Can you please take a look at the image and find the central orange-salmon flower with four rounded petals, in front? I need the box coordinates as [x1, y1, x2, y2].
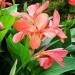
[13, 13, 49, 50]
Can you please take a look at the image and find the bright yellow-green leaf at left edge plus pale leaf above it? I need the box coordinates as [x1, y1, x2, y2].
[0, 5, 17, 42]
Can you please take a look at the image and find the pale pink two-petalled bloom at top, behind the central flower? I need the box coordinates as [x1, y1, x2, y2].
[27, 1, 49, 17]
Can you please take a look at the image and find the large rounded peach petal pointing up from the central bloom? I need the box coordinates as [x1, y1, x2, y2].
[35, 13, 49, 30]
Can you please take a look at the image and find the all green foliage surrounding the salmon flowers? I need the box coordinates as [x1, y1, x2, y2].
[0, 0, 75, 75]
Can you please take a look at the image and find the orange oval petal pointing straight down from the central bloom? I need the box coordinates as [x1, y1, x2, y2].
[30, 34, 41, 50]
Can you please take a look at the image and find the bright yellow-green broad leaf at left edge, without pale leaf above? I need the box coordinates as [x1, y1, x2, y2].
[0, 10, 15, 42]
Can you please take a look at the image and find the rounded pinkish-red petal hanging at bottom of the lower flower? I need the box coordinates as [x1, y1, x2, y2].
[38, 56, 52, 69]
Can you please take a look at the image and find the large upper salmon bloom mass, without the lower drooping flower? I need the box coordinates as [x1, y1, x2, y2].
[13, 1, 66, 50]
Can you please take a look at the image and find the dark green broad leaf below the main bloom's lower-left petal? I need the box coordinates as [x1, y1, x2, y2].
[7, 35, 31, 65]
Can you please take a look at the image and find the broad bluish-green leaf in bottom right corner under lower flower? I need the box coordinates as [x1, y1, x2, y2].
[37, 57, 75, 75]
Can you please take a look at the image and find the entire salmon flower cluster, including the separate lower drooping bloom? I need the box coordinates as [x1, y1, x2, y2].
[12, 1, 67, 69]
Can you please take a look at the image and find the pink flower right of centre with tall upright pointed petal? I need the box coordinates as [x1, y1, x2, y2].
[44, 10, 67, 43]
